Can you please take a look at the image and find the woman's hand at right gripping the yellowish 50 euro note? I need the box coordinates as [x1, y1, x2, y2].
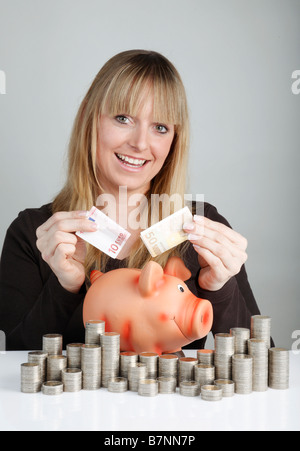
[183, 215, 248, 291]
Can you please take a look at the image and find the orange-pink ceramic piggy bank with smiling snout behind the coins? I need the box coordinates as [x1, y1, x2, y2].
[83, 257, 213, 355]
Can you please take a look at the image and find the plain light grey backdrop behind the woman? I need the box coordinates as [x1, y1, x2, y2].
[0, 0, 300, 348]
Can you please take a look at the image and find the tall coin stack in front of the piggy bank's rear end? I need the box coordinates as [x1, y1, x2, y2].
[100, 332, 120, 388]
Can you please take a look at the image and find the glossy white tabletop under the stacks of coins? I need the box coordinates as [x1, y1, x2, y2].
[0, 351, 300, 437]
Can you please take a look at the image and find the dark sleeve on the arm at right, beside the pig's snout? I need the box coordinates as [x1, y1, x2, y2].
[185, 204, 260, 348]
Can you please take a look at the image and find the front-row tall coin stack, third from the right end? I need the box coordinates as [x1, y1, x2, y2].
[232, 354, 253, 395]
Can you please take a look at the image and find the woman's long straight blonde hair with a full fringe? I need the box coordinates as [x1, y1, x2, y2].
[52, 50, 189, 275]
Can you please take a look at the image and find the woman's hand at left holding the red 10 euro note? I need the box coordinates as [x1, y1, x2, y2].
[36, 211, 97, 293]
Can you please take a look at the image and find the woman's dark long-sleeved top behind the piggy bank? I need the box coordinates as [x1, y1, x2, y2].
[0, 203, 260, 351]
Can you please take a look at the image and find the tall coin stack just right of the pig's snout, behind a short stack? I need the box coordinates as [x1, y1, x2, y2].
[214, 333, 235, 379]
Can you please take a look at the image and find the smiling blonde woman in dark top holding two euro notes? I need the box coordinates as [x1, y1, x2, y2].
[0, 50, 259, 349]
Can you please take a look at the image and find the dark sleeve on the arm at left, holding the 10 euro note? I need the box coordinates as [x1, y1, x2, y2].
[0, 209, 85, 350]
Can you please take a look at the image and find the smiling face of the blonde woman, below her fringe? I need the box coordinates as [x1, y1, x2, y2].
[97, 97, 174, 194]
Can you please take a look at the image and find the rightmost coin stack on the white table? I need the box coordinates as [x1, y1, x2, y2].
[269, 348, 289, 390]
